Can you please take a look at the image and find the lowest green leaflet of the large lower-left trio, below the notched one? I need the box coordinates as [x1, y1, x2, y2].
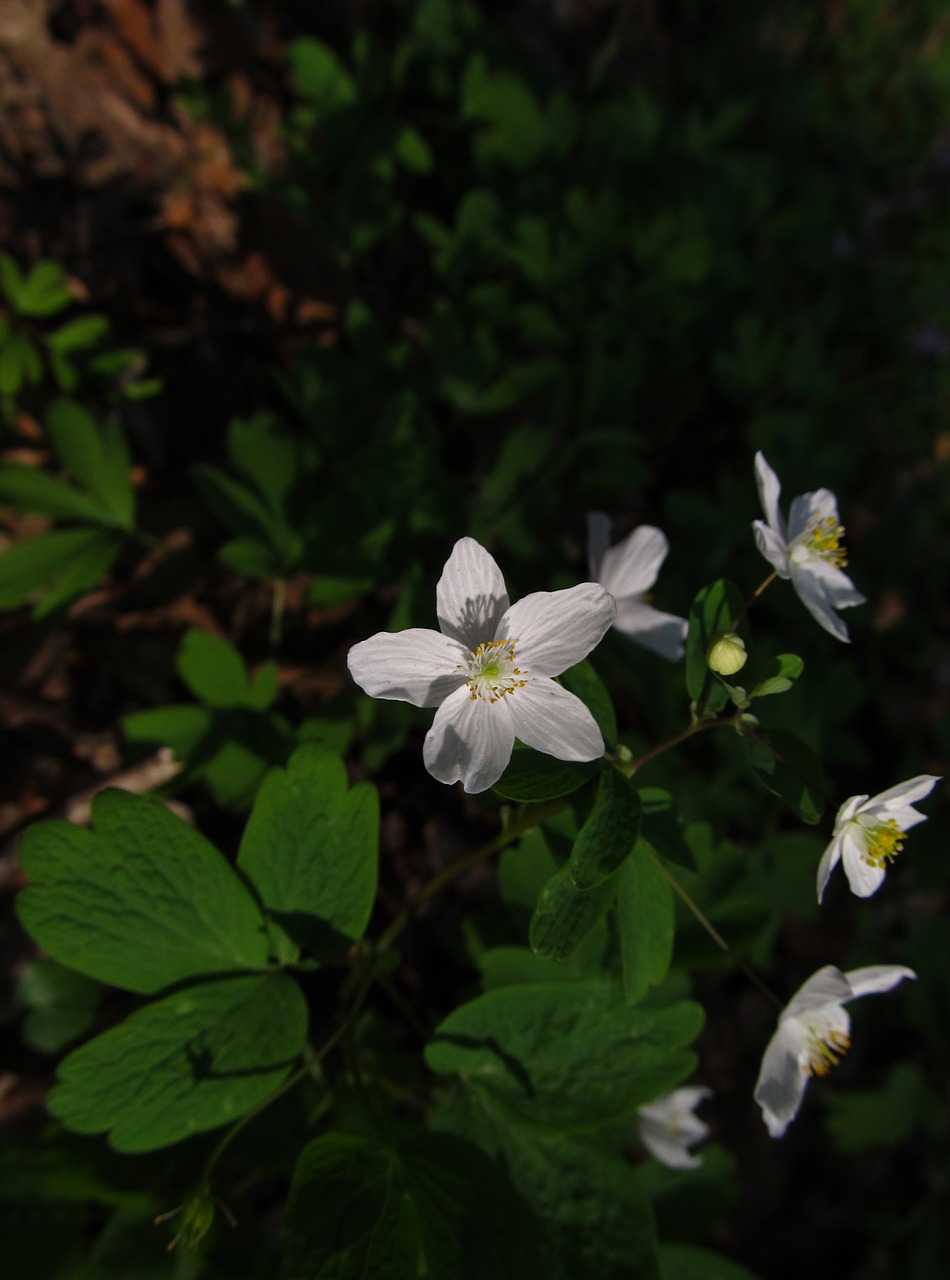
[47, 973, 307, 1152]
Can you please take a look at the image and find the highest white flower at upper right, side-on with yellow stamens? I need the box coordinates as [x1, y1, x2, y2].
[753, 453, 864, 643]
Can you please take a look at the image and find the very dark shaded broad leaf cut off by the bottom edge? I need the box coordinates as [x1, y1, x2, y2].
[279, 1133, 473, 1280]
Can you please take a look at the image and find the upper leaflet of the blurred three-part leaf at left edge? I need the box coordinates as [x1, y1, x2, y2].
[46, 399, 136, 529]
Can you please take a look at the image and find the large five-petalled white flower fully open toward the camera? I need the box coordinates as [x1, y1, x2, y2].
[347, 538, 616, 792]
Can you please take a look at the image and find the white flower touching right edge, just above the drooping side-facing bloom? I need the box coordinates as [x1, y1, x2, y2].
[818, 773, 940, 902]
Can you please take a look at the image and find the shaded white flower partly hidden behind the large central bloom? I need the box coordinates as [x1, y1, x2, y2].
[588, 511, 688, 662]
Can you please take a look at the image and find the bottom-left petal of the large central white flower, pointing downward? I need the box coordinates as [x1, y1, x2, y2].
[423, 689, 515, 794]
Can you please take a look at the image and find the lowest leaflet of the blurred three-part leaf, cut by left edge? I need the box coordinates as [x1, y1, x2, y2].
[0, 529, 120, 614]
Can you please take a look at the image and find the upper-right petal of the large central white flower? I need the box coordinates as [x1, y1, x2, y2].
[494, 582, 617, 678]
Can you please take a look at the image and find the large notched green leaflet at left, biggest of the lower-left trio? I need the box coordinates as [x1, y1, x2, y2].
[17, 791, 268, 993]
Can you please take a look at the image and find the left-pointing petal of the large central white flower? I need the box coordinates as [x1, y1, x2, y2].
[347, 627, 467, 707]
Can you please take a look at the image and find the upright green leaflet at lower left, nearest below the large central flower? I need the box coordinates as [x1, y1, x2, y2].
[238, 744, 379, 960]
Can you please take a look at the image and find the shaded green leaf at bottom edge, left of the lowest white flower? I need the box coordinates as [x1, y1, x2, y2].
[435, 1082, 657, 1280]
